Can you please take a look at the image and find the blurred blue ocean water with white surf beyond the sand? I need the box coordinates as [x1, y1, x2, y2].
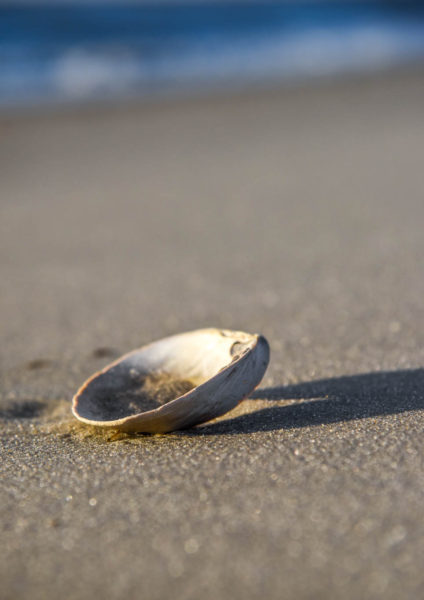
[0, 0, 424, 107]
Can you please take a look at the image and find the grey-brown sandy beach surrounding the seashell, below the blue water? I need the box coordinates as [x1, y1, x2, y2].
[0, 71, 424, 600]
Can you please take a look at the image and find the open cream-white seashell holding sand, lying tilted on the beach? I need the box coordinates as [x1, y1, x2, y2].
[72, 329, 269, 433]
